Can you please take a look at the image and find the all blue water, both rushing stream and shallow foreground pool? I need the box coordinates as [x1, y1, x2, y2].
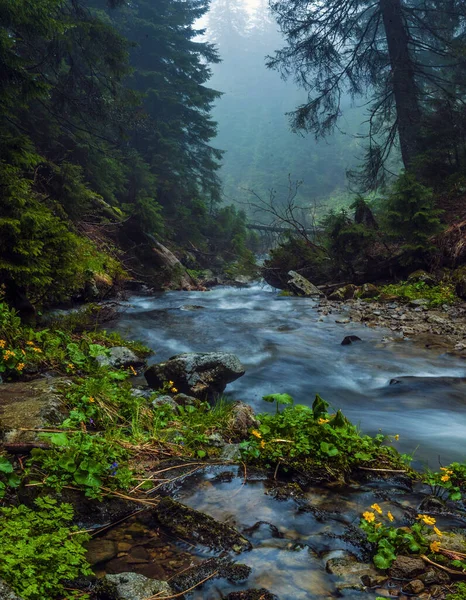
[104, 285, 466, 600]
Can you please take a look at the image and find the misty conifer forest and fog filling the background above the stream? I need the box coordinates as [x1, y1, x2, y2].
[0, 0, 466, 312]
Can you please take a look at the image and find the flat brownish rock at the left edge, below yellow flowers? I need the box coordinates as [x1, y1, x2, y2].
[0, 377, 71, 444]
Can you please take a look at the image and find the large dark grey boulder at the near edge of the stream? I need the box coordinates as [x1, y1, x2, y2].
[145, 352, 245, 399]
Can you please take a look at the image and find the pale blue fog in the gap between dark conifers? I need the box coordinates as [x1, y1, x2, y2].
[201, 0, 365, 212]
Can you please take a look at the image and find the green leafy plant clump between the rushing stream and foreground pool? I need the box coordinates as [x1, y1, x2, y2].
[241, 394, 408, 473]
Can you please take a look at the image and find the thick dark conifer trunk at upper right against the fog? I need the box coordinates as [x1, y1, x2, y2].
[379, 0, 421, 170]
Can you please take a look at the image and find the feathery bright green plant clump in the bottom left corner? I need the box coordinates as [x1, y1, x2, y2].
[0, 497, 92, 600]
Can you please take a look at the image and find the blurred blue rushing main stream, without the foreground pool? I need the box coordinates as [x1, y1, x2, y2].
[117, 285, 466, 467]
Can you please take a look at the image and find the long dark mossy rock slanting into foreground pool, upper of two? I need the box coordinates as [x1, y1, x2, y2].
[154, 497, 251, 552]
